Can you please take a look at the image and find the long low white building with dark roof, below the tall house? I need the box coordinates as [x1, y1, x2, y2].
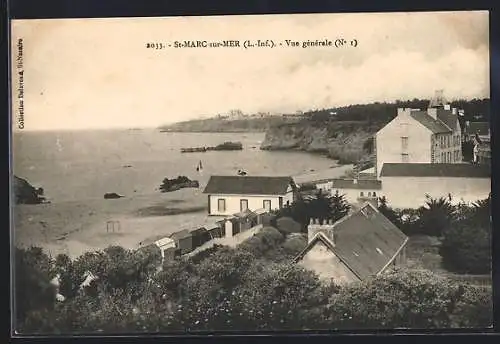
[380, 163, 491, 208]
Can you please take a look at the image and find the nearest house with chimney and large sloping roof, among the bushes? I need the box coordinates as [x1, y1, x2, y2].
[294, 203, 408, 284]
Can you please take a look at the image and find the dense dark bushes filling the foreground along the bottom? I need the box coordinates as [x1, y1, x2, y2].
[16, 223, 492, 333]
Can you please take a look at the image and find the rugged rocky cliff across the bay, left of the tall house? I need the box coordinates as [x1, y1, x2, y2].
[260, 120, 385, 166]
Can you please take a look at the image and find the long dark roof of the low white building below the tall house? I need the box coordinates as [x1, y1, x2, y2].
[380, 163, 491, 178]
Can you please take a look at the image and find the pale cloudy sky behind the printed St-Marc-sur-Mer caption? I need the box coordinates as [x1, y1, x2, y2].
[11, 11, 490, 130]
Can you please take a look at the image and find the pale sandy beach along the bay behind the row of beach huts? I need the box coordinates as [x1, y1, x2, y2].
[13, 165, 351, 258]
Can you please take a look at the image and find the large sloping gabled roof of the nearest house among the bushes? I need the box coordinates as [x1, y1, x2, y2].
[294, 203, 408, 279]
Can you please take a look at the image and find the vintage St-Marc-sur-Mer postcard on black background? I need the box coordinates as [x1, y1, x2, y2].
[10, 11, 492, 335]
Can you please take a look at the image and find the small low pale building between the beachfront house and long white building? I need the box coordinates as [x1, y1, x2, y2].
[315, 178, 382, 204]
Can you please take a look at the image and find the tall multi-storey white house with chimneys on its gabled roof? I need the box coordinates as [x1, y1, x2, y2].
[375, 104, 462, 177]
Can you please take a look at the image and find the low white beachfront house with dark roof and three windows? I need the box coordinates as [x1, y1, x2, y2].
[203, 176, 297, 216]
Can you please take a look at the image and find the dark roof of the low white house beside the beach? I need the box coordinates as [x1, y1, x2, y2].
[203, 176, 293, 195]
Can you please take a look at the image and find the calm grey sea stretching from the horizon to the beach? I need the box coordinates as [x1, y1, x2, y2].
[12, 129, 334, 203]
